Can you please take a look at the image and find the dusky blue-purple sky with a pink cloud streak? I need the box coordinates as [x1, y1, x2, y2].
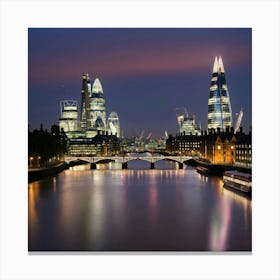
[28, 28, 252, 137]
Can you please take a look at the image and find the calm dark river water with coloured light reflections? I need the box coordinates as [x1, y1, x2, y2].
[28, 158, 252, 252]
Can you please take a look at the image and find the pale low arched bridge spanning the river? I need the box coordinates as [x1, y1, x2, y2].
[65, 155, 192, 169]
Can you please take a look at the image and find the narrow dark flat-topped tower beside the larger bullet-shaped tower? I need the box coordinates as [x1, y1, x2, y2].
[80, 74, 91, 130]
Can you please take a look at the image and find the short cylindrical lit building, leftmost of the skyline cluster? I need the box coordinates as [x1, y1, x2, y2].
[59, 100, 79, 135]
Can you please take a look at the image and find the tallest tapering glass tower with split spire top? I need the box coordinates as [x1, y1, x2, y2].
[208, 56, 232, 131]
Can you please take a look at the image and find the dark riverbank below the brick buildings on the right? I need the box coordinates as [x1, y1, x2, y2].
[186, 159, 252, 177]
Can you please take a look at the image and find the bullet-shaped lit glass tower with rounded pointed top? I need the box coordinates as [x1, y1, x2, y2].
[90, 78, 106, 131]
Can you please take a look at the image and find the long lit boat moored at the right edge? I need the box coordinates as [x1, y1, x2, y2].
[223, 170, 252, 193]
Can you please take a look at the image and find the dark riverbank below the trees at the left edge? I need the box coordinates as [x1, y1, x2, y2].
[28, 162, 69, 183]
